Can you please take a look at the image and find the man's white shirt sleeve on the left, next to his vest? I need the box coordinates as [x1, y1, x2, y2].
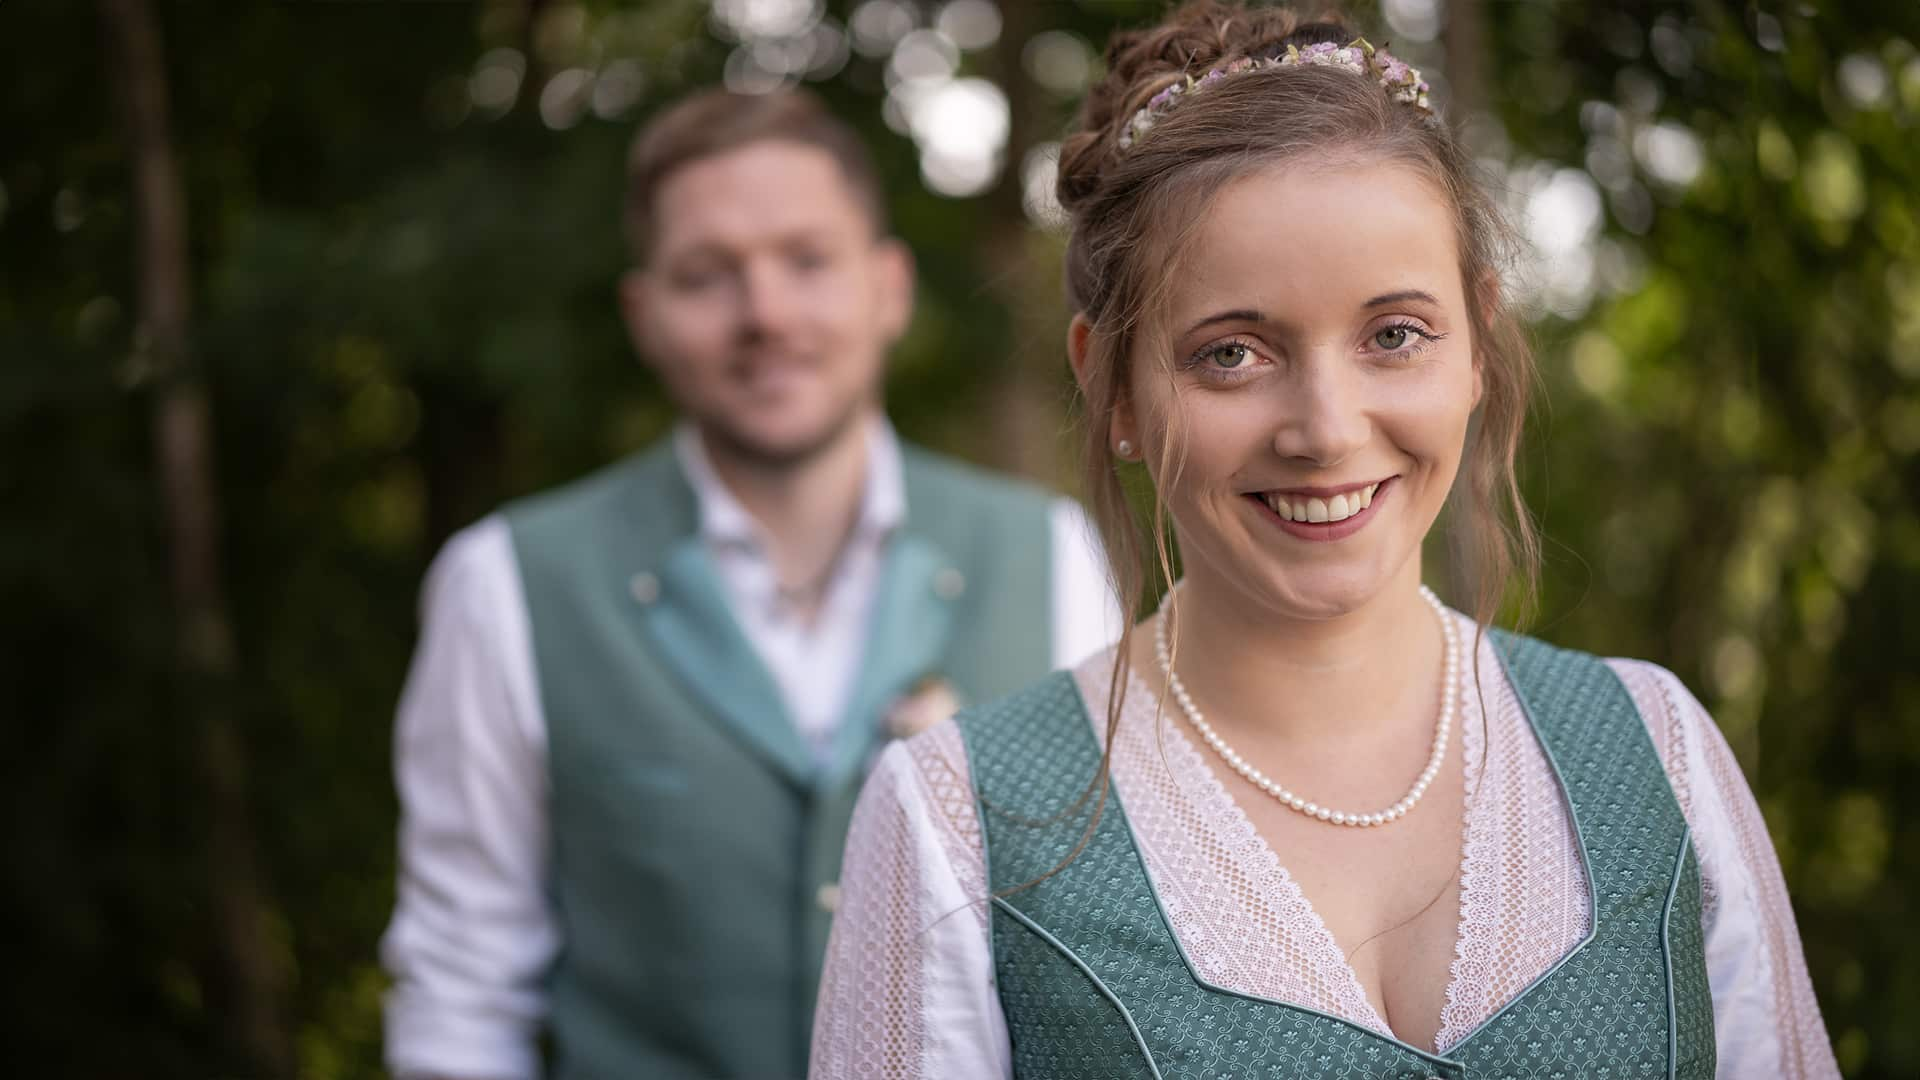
[380, 517, 557, 1080]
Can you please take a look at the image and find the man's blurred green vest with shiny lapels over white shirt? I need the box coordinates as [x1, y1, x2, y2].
[507, 446, 1052, 1080]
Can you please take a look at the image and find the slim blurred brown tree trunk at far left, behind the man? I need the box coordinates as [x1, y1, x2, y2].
[100, 0, 292, 1076]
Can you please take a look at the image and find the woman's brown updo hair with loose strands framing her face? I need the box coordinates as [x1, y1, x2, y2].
[1058, 0, 1538, 868]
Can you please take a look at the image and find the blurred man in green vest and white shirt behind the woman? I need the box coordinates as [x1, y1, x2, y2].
[382, 92, 1117, 1080]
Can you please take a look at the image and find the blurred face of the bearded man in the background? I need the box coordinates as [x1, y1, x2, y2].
[620, 140, 912, 465]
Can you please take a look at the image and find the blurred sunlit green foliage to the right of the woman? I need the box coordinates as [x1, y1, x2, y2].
[1496, 4, 1920, 1076]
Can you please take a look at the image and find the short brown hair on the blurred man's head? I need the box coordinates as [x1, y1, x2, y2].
[624, 88, 887, 261]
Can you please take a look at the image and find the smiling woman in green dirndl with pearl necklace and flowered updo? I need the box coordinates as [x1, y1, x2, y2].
[814, 4, 1837, 1078]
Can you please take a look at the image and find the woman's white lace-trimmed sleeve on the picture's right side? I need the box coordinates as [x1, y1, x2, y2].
[1613, 661, 1839, 1080]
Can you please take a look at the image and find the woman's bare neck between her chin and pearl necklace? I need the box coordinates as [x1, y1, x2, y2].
[1135, 561, 1444, 748]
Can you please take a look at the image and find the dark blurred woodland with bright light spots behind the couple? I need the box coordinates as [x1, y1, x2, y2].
[0, 0, 1920, 1078]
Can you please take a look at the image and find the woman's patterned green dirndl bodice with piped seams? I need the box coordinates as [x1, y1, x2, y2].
[960, 630, 1715, 1080]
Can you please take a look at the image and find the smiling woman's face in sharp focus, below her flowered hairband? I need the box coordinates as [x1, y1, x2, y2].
[1112, 155, 1480, 619]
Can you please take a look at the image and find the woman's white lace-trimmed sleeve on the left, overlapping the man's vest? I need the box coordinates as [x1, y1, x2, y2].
[810, 721, 1012, 1080]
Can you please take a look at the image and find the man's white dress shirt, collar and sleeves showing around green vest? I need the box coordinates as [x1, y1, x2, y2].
[380, 421, 1119, 1078]
